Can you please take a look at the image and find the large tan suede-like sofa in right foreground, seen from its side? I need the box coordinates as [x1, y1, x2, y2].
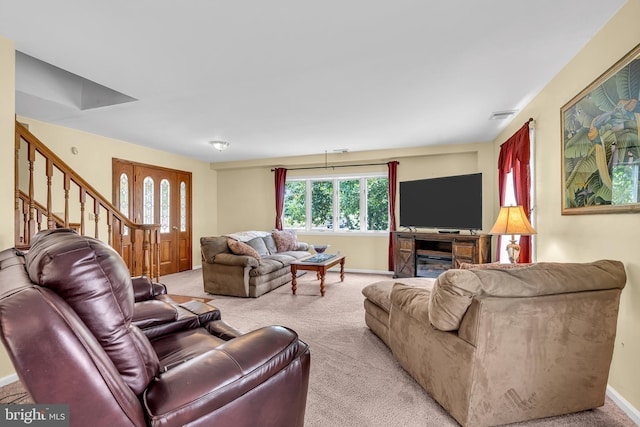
[363, 260, 626, 426]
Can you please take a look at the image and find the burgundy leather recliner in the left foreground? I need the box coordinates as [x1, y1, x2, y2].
[0, 230, 310, 427]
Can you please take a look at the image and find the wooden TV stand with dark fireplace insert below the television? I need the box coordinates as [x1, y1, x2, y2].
[393, 231, 491, 277]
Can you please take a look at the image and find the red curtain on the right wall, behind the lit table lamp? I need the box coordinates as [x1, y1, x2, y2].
[496, 119, 533, 263]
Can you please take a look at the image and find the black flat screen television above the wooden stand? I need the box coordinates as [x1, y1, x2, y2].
[399, 173, 482, 231]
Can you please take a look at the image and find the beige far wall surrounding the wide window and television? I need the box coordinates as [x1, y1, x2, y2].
[212, 143, 496, 272]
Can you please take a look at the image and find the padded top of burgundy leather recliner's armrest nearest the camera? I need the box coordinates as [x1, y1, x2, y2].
[143, 326, 308, 425]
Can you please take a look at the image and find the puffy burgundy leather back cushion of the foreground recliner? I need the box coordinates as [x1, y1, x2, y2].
[25, 229, 160, 394]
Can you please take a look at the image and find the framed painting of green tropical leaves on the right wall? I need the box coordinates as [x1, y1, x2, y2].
[560, 45, 640, 215]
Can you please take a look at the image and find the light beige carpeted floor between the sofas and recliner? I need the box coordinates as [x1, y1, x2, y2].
[0, 270, 635, 427]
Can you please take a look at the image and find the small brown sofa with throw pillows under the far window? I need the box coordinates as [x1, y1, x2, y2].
[200, 231, 311, 298]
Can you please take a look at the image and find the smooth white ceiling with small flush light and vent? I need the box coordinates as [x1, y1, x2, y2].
[0, 0, 626, 162]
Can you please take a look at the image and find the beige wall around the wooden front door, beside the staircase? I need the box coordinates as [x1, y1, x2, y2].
[12, 117, 217, 266]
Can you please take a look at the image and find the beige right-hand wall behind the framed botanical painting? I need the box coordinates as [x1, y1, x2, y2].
[494, 0, 640, 408]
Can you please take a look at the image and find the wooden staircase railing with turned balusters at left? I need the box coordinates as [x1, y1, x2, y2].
[15, 121, 160, 280]
